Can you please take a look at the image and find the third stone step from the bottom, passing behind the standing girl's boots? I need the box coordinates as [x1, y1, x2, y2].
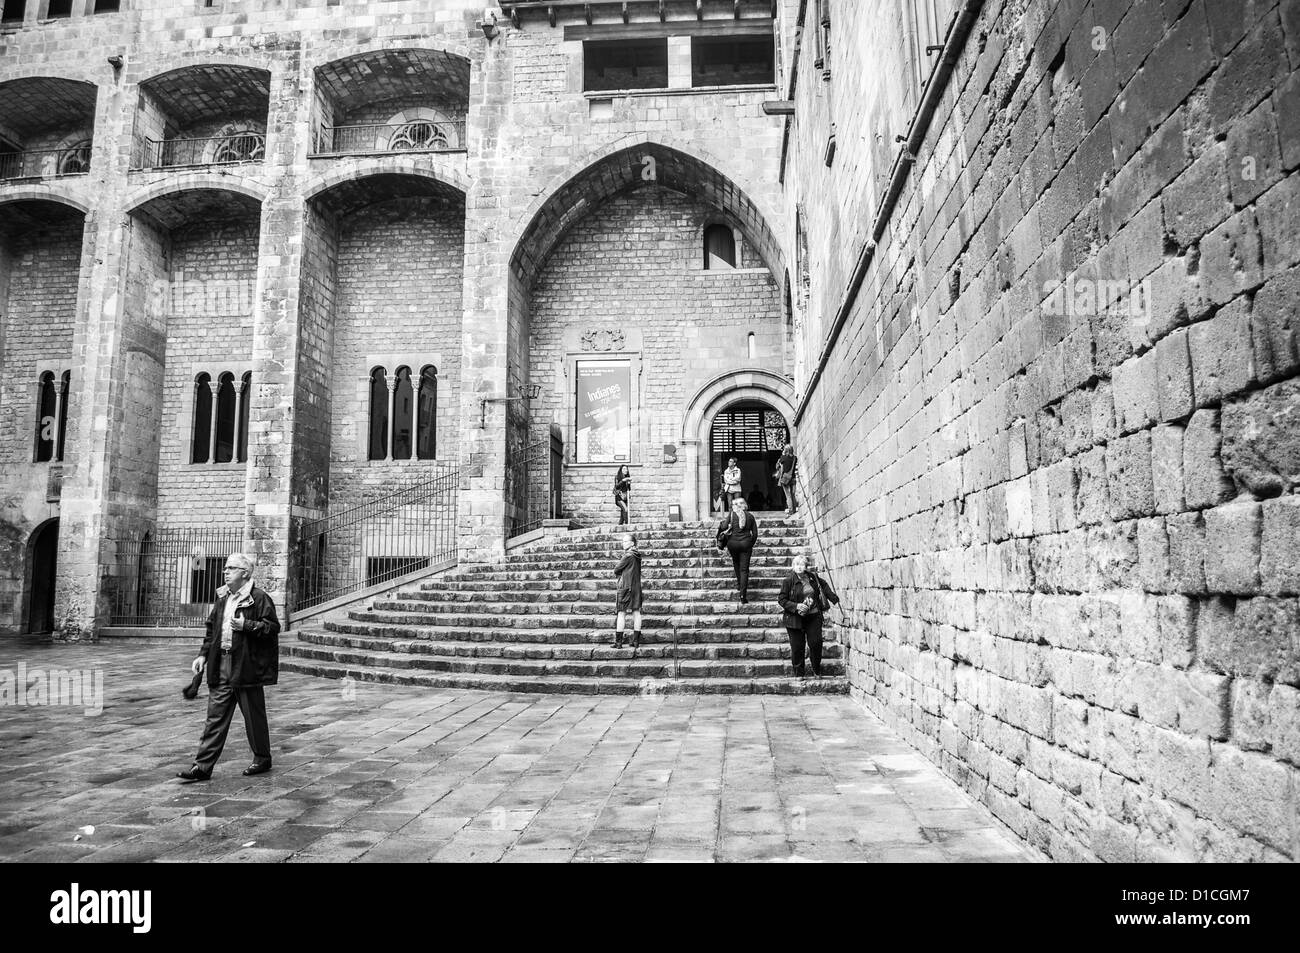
[321, 610, 800, 645]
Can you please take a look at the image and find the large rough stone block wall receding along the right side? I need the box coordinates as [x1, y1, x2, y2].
[788, 0, 1300, 861]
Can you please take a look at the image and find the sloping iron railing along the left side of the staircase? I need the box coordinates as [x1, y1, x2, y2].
[293, 463, 460, 612]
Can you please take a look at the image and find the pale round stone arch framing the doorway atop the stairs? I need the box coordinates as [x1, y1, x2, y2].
[681, 369, 794, 519]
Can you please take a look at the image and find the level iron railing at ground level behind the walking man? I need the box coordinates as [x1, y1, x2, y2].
[109, 525, 244, 628]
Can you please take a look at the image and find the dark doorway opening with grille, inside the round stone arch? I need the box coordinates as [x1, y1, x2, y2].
[709, 399, 789, 512]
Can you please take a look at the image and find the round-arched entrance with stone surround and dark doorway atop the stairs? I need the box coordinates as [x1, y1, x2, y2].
[681, 368, 798, 520]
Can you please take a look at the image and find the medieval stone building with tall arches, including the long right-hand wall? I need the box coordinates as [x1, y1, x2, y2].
[0, 0, 1300, 859]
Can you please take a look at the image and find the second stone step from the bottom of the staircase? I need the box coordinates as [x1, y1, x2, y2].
[298, 629, 842, 660]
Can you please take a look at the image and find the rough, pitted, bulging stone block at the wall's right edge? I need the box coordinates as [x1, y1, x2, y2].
[1216, 380, 1300, 497]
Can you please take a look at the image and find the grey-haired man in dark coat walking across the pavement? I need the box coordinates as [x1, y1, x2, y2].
[177, 553, 280, 781]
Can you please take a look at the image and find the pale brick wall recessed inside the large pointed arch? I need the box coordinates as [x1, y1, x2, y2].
[529, 187, 784, 520]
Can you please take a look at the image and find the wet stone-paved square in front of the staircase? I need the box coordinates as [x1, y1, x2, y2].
[0, 641, 1035, 862]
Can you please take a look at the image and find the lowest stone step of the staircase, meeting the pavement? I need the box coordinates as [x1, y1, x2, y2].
[280, 657, 849, 696]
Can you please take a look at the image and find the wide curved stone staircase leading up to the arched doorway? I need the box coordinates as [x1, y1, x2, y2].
[281, 515, 848, 694]
